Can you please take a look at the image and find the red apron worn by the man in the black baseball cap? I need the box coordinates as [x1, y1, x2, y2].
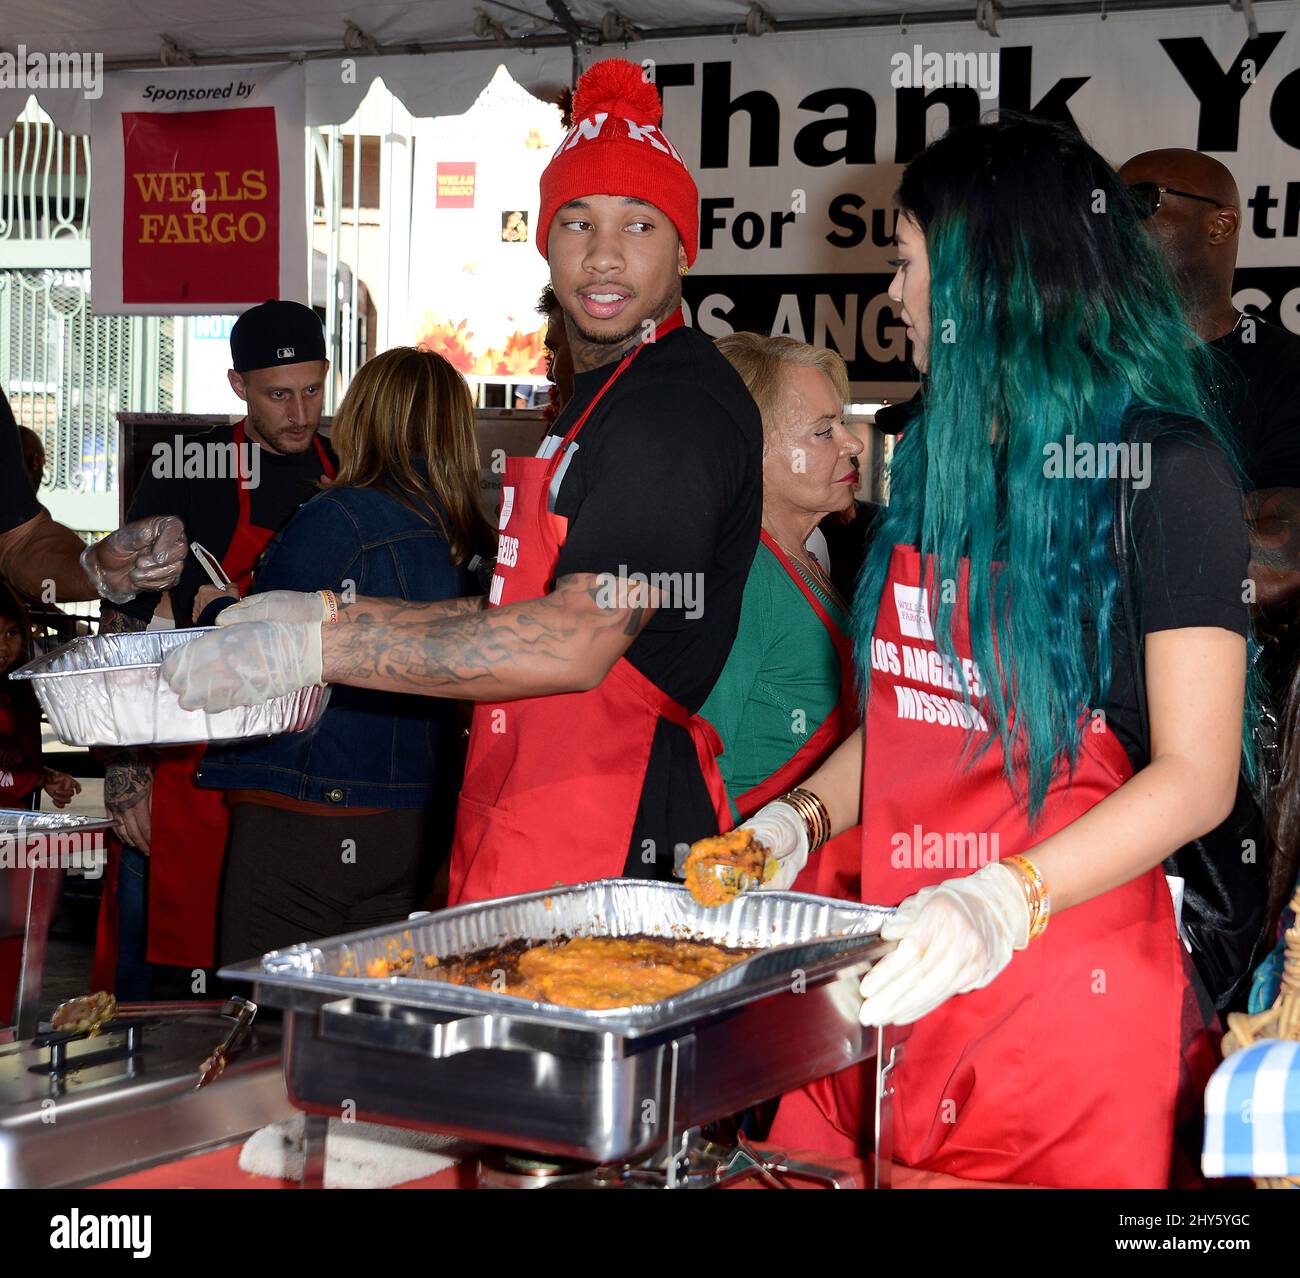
[95, 419, 334, 972]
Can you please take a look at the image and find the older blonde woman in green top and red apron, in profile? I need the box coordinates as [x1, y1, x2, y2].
[699, 333, 862, 893]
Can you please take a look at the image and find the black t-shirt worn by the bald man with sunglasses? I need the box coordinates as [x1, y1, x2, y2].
[1209, 316, 1300, 489]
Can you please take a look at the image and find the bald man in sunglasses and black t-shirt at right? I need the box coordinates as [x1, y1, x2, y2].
[1119, 150, 1300, 619]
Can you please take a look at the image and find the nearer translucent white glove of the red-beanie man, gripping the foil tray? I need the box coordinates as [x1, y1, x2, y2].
[163, 621, 324, 712]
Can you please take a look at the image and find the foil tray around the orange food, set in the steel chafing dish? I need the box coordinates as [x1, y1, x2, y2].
[221, 879, 893, 1037]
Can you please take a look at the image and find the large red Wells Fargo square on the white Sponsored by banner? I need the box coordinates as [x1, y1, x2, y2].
[122, 107, 281, 306]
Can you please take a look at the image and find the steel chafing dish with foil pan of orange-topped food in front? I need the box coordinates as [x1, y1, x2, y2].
[221, 879, 891, 1162]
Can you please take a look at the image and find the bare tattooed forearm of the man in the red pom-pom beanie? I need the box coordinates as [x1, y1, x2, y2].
[322, 573, 654, 701]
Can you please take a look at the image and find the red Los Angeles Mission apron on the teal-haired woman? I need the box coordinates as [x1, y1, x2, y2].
[771, 546, 1186, 1188]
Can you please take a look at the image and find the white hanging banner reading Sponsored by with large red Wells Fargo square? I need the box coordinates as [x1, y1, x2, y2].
[91, 68, 307, 315]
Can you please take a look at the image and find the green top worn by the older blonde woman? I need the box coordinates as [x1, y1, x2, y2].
[699, 543, 848, 820]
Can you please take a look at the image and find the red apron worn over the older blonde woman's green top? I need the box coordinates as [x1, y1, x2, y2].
[736, 528, 862, 898]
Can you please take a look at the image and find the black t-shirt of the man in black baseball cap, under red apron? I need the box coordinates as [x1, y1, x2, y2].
[113, 425, 335, 627]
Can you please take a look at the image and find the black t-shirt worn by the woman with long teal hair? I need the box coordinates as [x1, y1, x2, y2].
[1086, 417, 1251, 770]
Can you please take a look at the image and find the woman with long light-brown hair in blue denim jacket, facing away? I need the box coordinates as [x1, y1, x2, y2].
[199, 347, 493, 963]
